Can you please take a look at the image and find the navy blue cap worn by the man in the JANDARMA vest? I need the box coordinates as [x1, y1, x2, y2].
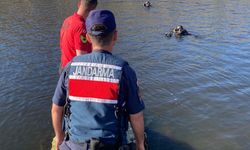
[86, 10, 116, 36]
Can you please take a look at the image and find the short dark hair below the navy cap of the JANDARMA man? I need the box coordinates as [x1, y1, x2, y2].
[89, 24, 115, 46]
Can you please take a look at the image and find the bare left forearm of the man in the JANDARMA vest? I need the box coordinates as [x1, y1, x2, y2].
[51, 104, 65, 150]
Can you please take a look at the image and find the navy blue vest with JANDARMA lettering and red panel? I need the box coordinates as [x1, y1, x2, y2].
[67, 51, 127, 144]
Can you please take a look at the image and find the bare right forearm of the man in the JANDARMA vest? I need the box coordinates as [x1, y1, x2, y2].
[129, 111, 145, 150]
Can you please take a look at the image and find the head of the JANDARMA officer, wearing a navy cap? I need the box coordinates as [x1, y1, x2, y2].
[86, 10, 117, 51]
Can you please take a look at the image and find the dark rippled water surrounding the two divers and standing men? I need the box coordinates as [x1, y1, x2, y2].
[0, 0, 250, 150]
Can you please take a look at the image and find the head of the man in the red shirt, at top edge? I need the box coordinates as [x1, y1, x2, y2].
[77, 0, 98, 19]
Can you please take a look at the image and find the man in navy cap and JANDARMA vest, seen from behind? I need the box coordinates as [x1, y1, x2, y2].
[51, 10, 145, 150]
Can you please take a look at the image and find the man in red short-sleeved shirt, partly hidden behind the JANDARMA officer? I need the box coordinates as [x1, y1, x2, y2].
[60, 0, 97, 72]
